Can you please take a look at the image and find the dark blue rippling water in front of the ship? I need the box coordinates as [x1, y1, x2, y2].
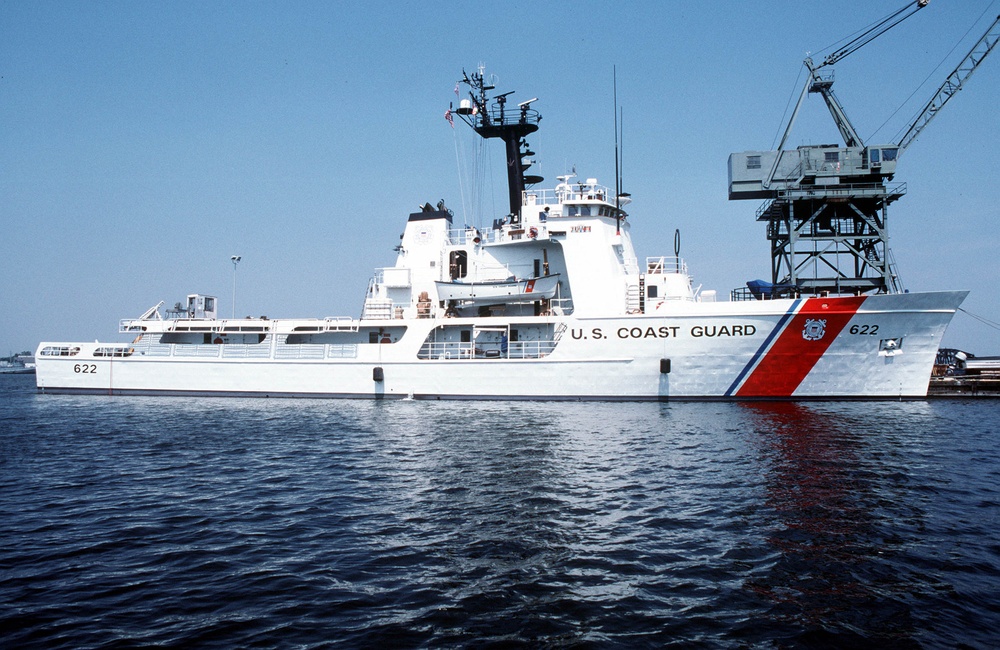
[0, 376, 1000, 648]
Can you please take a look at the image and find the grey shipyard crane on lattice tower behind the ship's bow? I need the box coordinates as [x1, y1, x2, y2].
[729, 0, 1000, 298]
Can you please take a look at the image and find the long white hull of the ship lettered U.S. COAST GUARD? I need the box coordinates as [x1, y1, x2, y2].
[36, 292, 966, 400]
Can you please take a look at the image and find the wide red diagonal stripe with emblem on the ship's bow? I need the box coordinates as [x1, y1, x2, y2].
[736, 296, 865, 397]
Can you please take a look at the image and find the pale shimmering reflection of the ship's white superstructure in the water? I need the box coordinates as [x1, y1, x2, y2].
[364, 403, 636, 641]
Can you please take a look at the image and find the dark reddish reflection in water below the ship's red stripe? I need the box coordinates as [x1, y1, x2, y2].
[743, 402, 913, 644]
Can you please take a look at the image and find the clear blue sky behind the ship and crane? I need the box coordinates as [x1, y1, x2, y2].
[0, 0, 1000, 355]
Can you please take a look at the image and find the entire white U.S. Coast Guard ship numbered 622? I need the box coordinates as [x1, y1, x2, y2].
[35, 69, 968, 401]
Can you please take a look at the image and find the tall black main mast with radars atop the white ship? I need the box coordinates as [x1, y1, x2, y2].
[456, 68, 543, 223]
